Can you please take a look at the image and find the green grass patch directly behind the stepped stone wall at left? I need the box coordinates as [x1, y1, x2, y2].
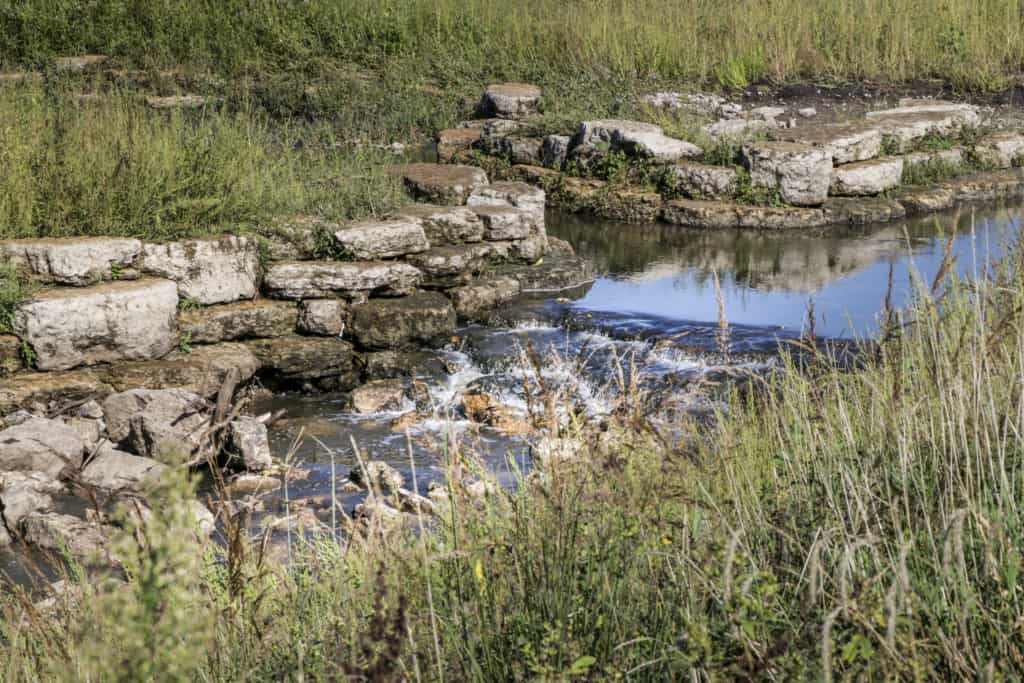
[0, 84, 401, 240]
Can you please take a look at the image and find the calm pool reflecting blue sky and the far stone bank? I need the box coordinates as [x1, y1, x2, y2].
[548, 207, 1022, 338]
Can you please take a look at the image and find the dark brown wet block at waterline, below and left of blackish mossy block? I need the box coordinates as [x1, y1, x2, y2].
[247, 335, 358, 381]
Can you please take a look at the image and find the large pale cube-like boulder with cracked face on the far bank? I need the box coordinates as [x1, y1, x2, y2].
[742, 142, 833, 206]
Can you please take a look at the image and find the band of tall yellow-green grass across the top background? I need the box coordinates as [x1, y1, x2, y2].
[0, 0, 1024, 89]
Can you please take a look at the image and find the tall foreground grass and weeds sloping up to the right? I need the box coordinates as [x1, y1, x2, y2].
[0, 240, 1024, 681]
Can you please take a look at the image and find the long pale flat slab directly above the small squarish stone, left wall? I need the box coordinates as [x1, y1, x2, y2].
[263, 261, 422, 299]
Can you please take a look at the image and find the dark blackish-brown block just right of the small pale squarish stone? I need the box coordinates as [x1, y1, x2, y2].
[352, 292, 456, 349]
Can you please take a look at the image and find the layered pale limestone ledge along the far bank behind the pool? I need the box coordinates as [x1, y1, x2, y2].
[437, 84, 1024, 229]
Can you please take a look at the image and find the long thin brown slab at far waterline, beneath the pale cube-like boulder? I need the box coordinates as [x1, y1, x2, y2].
[662, 200, 828, 230]
